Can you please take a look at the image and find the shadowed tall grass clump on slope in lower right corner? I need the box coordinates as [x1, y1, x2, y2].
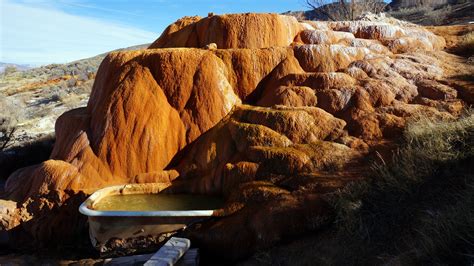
[334, 110, 474, 265]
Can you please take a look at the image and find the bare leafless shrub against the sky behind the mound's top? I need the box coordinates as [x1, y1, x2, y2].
[306, 0, 386, 21]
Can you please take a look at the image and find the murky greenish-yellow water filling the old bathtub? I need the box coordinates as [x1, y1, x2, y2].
[93, 194, 224, 211]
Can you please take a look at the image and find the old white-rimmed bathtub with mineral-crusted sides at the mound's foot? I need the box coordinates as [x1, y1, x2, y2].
[79, 183, 223, 248]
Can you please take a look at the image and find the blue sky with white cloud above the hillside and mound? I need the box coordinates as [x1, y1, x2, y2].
[0, 0, 305, 65]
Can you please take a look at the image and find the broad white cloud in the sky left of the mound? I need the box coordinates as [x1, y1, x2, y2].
[0, 0, 159, 64]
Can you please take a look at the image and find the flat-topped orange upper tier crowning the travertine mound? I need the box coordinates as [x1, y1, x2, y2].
[150, 13, 302, 49]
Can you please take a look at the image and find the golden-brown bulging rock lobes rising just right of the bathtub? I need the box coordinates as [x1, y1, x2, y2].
[171, 105, 357, 195]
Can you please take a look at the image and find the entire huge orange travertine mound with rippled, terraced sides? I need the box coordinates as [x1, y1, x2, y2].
[1, 11, 472, 258]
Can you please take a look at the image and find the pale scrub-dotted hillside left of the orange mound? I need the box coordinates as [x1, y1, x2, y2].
[0, 55, 101, 149]
